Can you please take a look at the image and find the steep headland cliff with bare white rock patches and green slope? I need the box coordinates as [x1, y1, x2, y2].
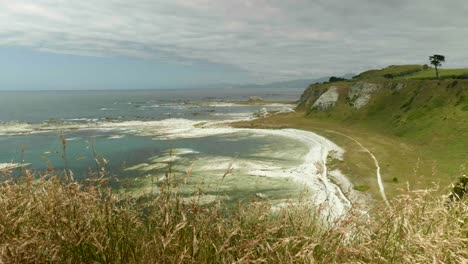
[297, 80, 468, 144]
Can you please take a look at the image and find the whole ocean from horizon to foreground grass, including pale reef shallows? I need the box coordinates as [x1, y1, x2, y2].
[0, 89, 318, 203]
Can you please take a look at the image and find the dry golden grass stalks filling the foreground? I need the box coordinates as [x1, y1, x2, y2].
[0, 172, 468, 263]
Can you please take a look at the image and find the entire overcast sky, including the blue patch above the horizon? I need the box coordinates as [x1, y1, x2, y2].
[0, 0, 468, 90]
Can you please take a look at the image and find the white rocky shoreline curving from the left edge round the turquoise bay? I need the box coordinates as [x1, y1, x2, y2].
[0, 107, 352, 222]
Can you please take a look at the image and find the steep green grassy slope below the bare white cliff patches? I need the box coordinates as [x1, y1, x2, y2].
[300, 80, 468, 143]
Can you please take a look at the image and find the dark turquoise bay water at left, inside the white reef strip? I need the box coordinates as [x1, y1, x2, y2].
[0, 130, 159, 178]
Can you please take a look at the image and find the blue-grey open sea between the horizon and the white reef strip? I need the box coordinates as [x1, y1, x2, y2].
[0, 89, 301, 123]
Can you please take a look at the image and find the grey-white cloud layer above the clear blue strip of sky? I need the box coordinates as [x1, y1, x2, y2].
[0, 0, 468, 82]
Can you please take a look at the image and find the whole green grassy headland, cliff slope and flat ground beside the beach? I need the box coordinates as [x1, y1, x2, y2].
[234, 65, 468, 198]
